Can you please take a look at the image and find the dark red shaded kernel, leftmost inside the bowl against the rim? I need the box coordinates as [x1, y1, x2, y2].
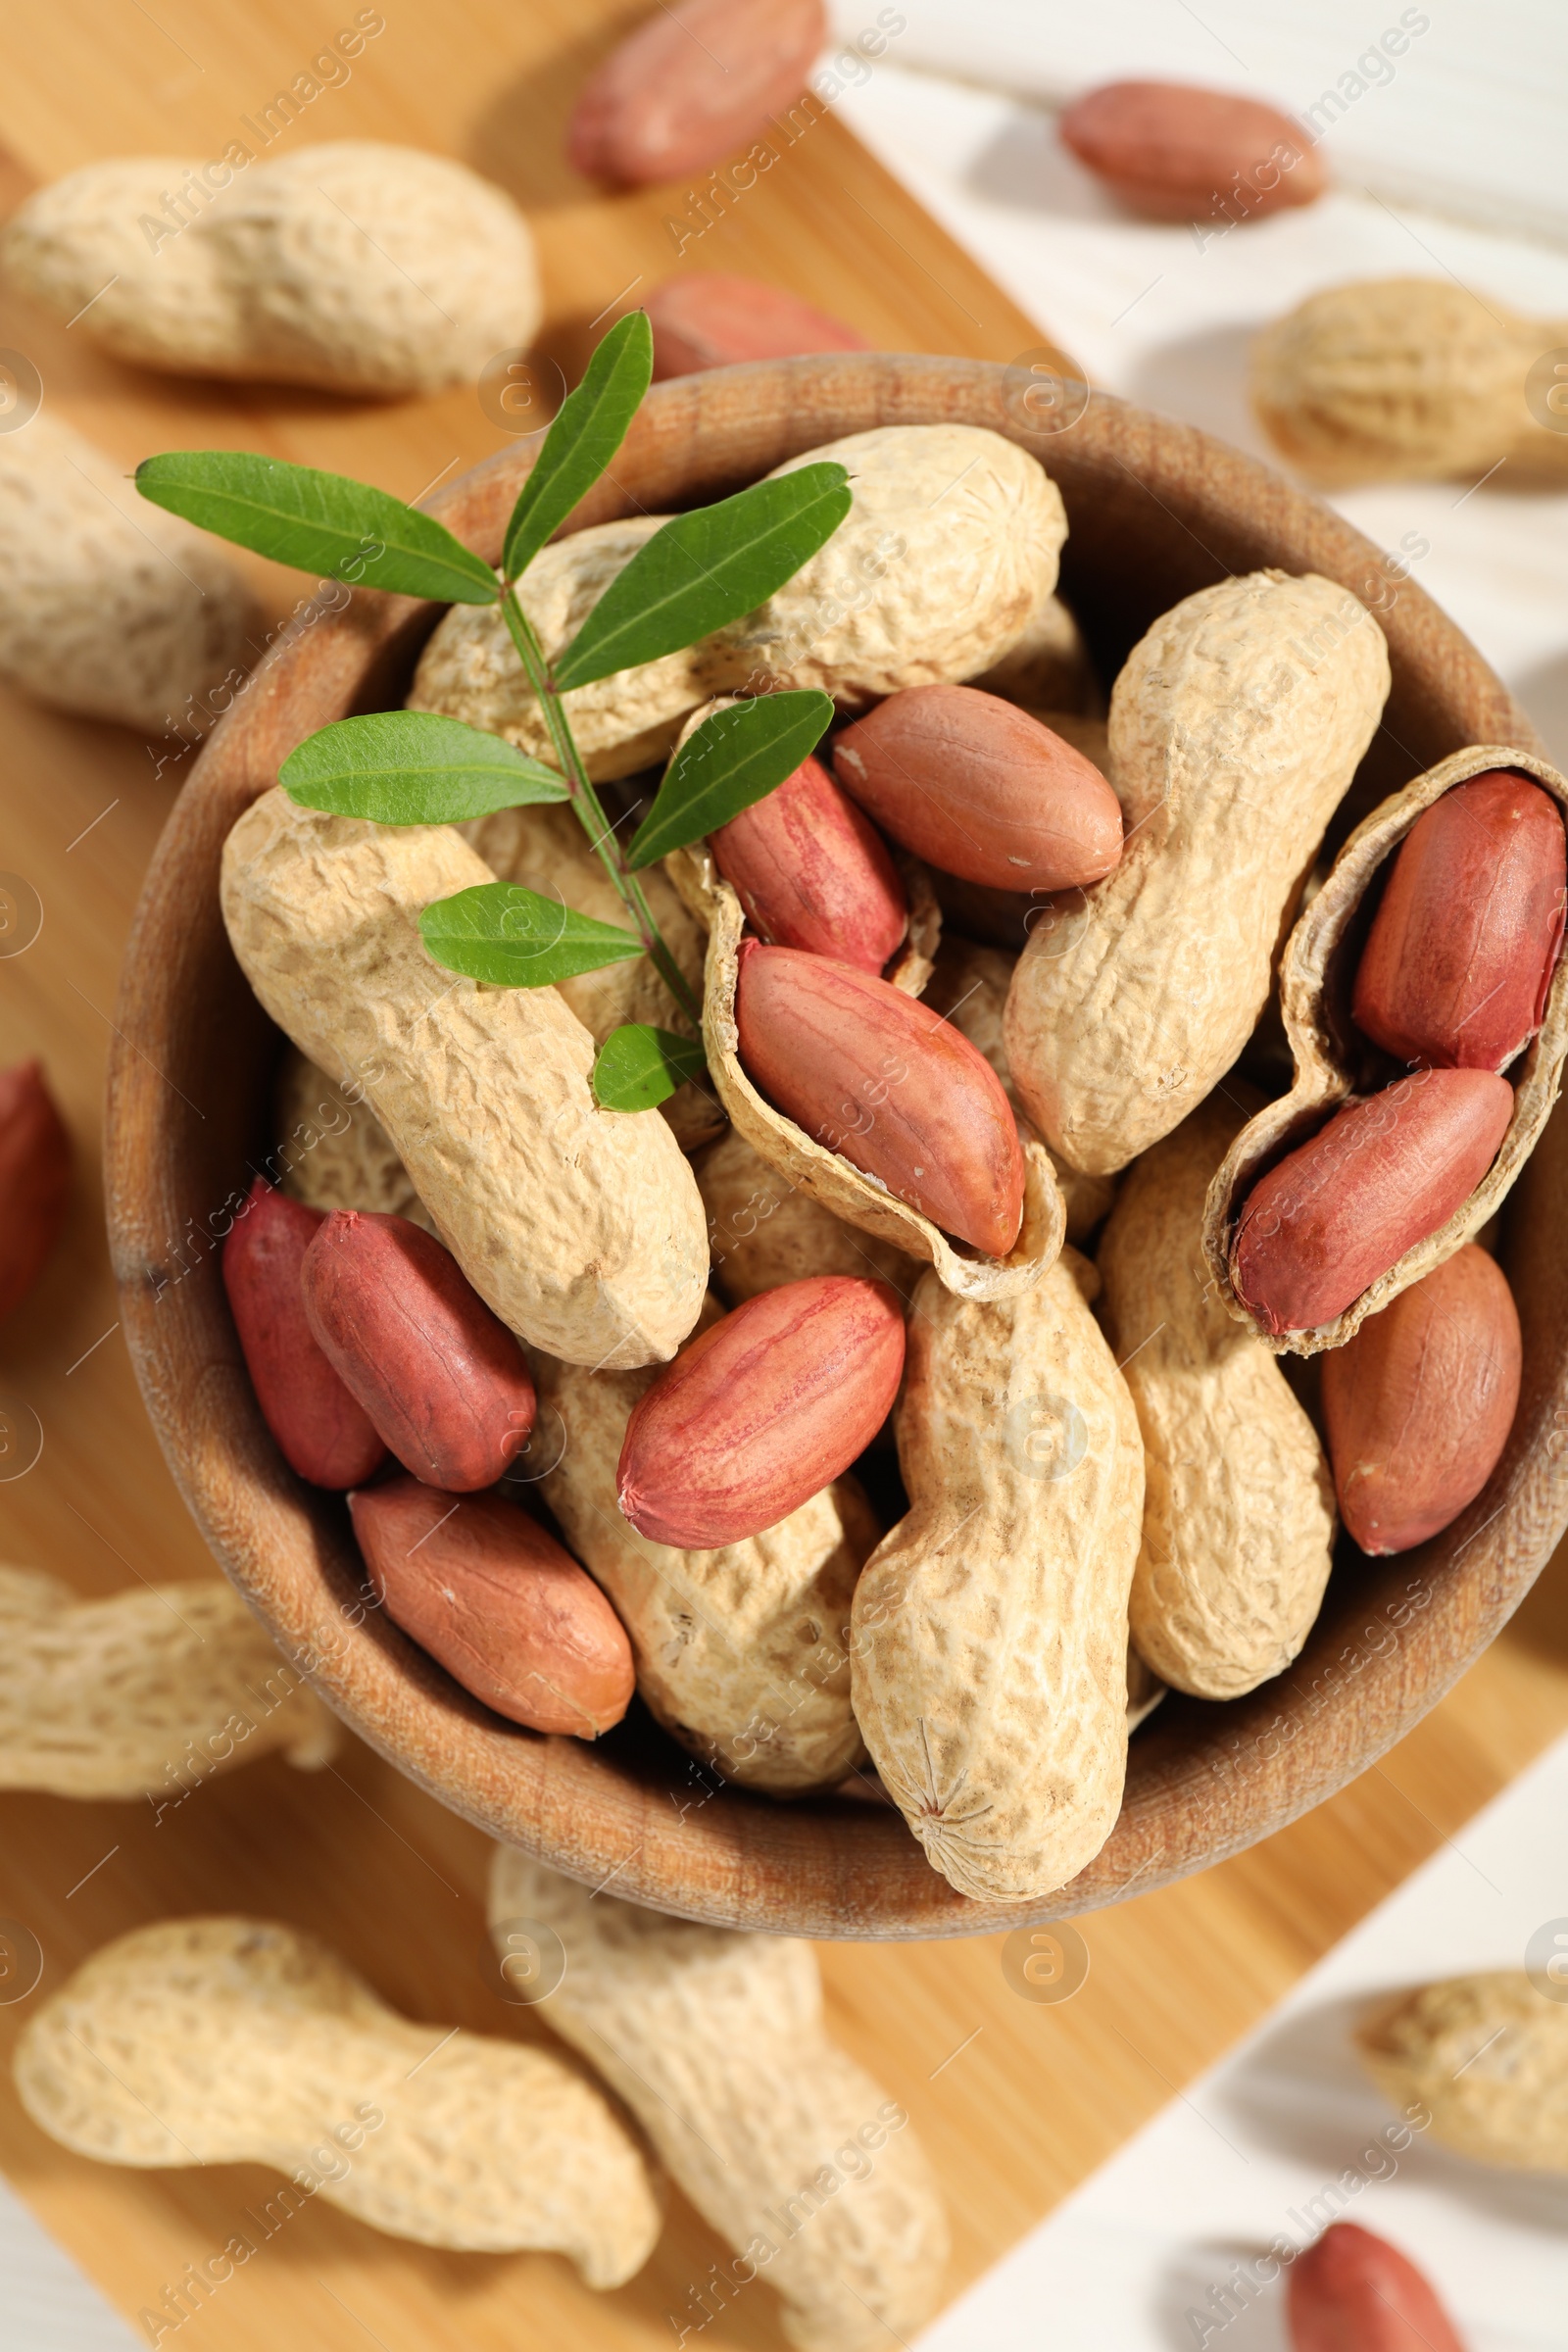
[223, 1176, 385, 1487]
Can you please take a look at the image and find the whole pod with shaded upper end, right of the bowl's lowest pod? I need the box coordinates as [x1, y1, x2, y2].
[1098, 1101, 1333, 1698]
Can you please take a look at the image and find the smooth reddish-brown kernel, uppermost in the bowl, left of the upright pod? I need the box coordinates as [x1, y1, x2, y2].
[832, 687, 1121, 892]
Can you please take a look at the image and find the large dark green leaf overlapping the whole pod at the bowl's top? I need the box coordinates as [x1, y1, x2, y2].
[555, 464, 854, 687]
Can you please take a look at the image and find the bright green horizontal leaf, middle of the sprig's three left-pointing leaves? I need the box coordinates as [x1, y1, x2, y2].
[277, 710, 566, 825]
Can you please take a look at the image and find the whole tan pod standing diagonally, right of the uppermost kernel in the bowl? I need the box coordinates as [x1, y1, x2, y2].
[1006, 571, 1390, 1174]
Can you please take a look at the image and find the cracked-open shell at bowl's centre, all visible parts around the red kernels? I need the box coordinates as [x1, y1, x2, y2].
[665, 842, 1067, 1298]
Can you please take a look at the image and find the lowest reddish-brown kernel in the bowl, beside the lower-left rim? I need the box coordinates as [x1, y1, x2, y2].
[348, 1477, 635, 1740]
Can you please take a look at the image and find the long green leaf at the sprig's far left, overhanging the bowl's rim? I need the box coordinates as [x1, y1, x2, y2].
[136, 449, 499, 605]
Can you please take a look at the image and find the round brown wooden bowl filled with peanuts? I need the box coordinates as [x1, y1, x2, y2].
[106, 355, 1568, 1938]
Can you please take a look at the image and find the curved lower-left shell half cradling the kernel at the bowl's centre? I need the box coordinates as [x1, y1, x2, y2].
[703, 882, 1067, 1298]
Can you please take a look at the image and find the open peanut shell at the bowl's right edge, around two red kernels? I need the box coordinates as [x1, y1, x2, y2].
[1203, 743, 1568, 1354]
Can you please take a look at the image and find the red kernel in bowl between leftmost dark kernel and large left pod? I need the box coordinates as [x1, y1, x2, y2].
[303, 1209, 534, 1494]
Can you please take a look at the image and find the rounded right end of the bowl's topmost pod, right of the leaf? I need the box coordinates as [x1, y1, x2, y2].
[710, 425, 1067, 710]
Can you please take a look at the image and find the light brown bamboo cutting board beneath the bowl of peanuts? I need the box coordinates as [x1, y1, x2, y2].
[0, 0, 1568, 2352]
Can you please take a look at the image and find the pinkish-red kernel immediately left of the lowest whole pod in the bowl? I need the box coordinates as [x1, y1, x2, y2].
[618, 1275, 903, 1552]
